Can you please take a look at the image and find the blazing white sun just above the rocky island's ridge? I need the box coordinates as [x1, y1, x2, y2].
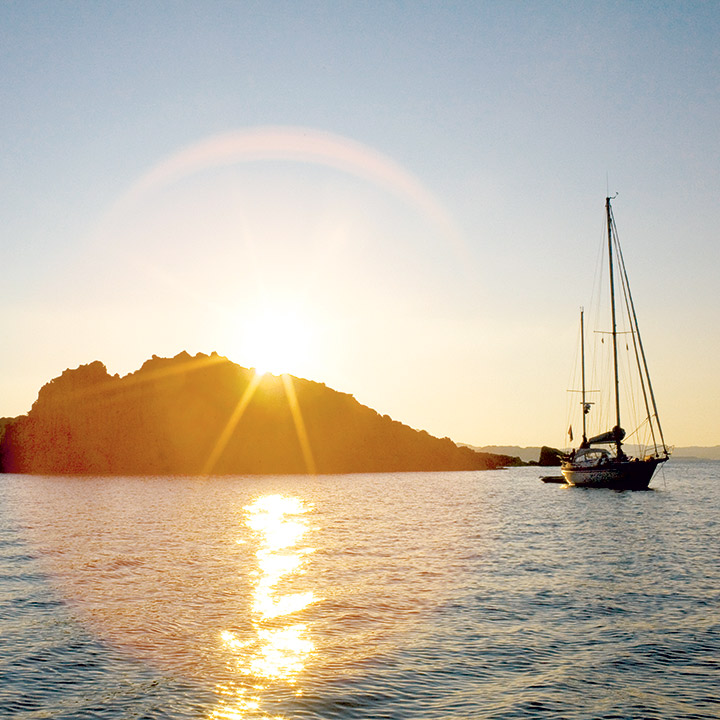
[241, 305, 315, 375]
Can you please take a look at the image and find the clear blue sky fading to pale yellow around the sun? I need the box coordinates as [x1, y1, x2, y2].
[0, 0, 720, 446]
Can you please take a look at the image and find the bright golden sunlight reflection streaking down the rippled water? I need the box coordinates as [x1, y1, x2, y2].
[209, 495, 317, 720]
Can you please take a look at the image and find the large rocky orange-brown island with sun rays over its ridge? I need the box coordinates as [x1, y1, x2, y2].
[0, 353, 522, 475]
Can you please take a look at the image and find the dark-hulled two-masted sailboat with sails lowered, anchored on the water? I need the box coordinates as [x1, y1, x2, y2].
[560, 197, 670, 490]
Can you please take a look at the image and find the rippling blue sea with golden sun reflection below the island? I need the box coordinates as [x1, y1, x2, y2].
[0, 461, 720, 720]
